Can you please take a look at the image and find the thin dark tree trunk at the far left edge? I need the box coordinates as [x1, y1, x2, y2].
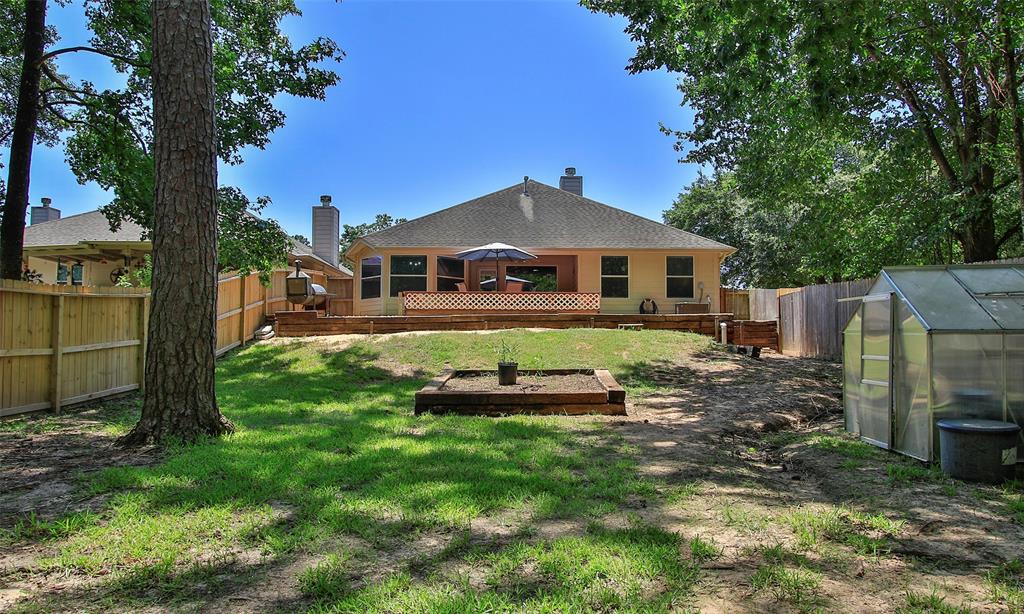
[0, 0, 46, 279]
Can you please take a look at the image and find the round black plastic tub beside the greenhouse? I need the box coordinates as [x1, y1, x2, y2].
[938, 418, 1021, 484]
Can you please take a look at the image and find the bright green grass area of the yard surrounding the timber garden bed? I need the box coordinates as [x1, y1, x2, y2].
[4, 330, 711, 612]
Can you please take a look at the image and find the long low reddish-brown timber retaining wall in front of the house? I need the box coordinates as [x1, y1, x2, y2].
[274, 311, 778, 350]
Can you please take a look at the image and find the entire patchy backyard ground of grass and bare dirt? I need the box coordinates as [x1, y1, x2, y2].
[0, 330, 1024, 612]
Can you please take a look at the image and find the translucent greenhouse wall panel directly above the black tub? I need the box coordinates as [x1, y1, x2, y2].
[932, 333, 1004, 420]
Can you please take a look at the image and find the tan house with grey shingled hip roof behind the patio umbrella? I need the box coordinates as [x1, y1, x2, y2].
[345, 169, 735, 315]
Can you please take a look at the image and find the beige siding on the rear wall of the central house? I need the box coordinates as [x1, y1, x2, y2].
[352, 247, 725, 315]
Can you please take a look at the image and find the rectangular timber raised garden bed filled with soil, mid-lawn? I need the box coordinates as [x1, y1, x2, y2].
[416, 368, 626, 415]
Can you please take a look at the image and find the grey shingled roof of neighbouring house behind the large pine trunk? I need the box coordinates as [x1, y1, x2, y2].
[25, 210, 352, 275]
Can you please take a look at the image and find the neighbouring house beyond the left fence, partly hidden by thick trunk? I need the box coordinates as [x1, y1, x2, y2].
[24, 196, 352, 286]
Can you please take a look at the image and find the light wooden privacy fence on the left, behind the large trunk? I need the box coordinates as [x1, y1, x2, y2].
[0, 271, 299, 415]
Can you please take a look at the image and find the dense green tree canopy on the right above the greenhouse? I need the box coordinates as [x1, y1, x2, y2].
[584, 0, 1024, 270]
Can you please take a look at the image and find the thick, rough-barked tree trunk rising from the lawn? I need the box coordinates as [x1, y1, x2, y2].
[122, 0, 232, 444]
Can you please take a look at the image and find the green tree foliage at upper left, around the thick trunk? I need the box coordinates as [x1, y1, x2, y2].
[0, 0, 343, 272]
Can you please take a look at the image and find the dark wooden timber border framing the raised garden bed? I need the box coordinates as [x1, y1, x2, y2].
[416, 368, 626, 415]
